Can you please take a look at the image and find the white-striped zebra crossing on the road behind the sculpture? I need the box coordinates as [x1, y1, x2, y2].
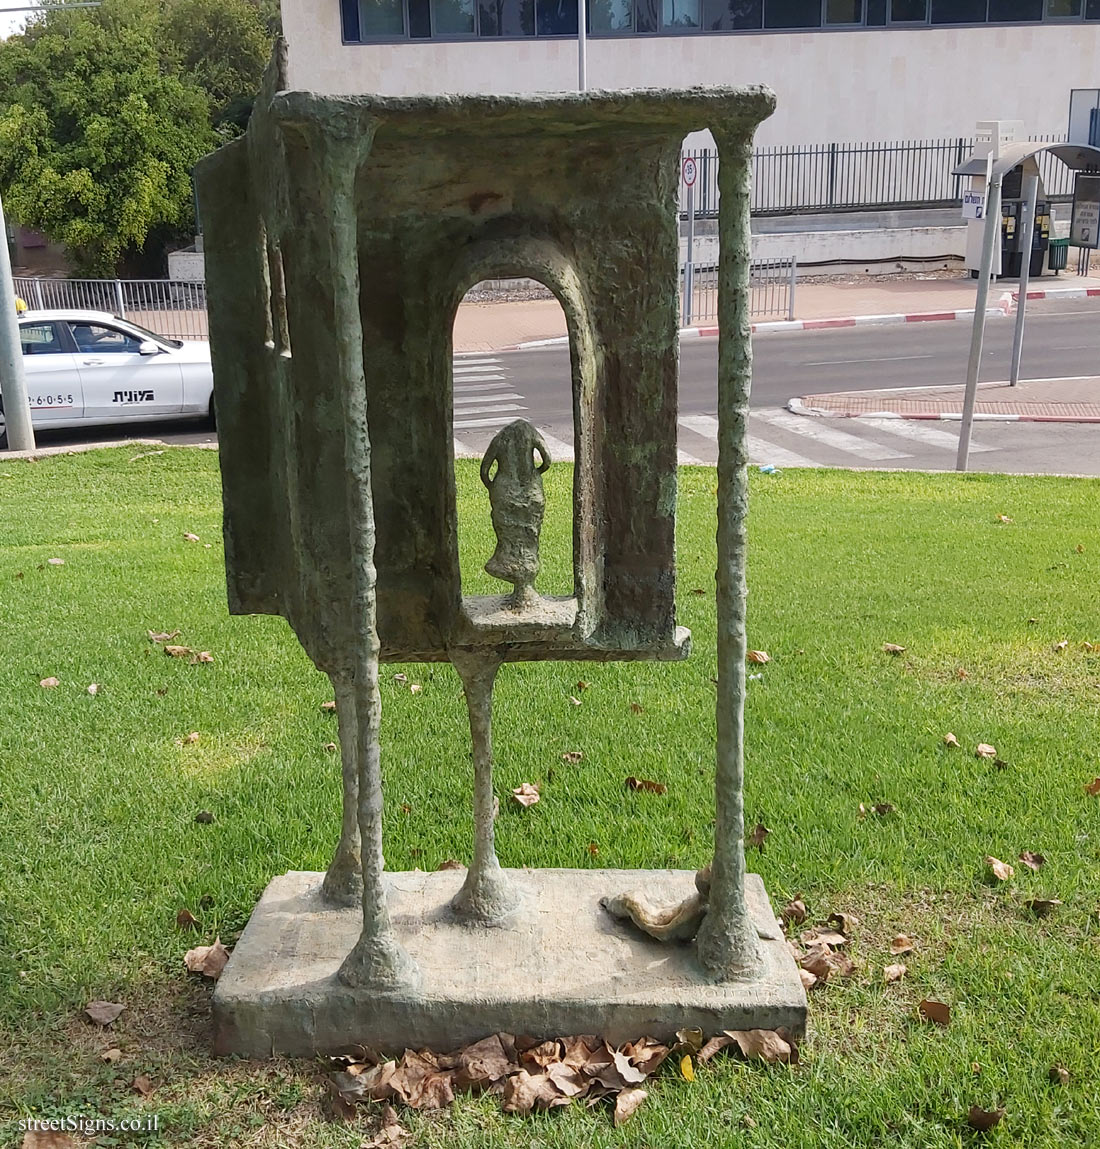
[441, 354, 997, 469]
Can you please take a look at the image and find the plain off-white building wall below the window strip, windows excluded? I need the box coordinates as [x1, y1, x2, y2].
[283, 10, 1100, 144]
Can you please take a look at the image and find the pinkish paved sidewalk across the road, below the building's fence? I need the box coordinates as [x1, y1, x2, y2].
[454, 272, 1100, 354]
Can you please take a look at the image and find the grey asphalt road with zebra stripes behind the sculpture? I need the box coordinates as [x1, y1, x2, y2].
[25, 300, 1100, 475]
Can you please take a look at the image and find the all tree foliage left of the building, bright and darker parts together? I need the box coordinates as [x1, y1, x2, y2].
[0, 0, 270, 275]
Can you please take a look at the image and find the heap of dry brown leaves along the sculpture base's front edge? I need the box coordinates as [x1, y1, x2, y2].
[329, 1030, 798, 1125]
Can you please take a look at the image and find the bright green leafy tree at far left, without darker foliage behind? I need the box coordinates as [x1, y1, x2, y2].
[0, 0, 216, 275]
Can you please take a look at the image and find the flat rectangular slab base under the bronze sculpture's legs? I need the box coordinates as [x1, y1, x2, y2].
[214, 870, 806, 1057]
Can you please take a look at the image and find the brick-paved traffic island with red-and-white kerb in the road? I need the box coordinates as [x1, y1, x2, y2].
[787, 376, 1100, 423]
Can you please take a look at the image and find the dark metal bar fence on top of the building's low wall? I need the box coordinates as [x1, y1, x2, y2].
[680, 134, 1074, 217]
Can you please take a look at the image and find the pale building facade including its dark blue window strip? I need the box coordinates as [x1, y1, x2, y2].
[283, 0, 1100, 145]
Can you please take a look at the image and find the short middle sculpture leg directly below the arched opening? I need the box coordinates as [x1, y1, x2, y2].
[451, 650, 520, 925]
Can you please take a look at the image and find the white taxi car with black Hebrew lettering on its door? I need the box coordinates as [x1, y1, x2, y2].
[0, 309, 214, 447]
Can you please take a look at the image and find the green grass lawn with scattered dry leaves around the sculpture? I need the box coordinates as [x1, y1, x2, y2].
[0, 448, 1100, 1149]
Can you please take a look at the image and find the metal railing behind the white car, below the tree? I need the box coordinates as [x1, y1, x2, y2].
[15, 277, 207, 339]
